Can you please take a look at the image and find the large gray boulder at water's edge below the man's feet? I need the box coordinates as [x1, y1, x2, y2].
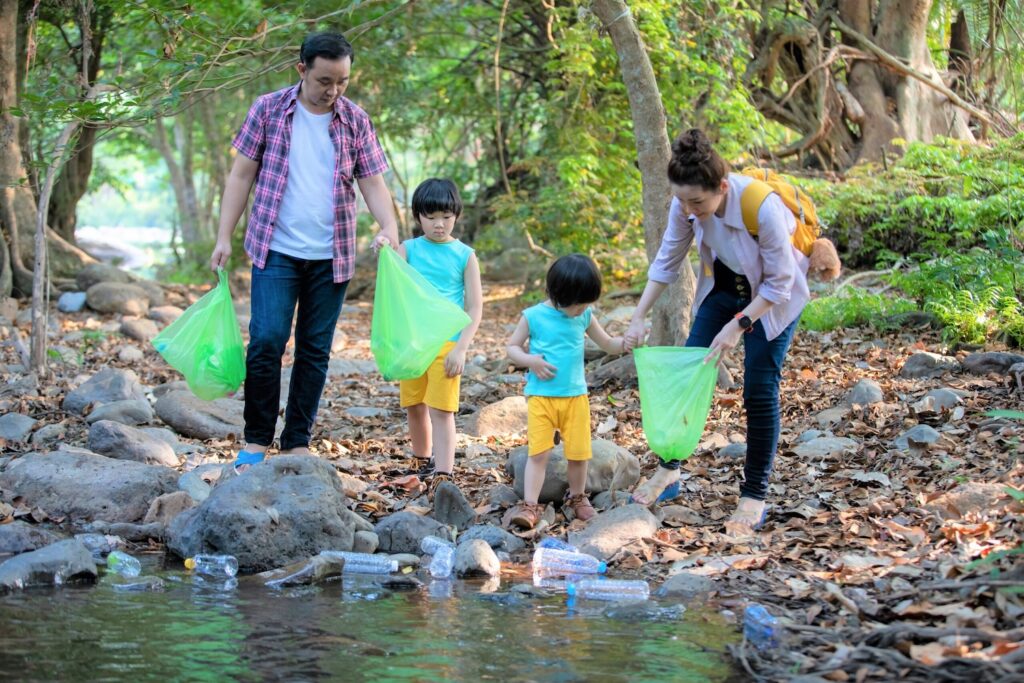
[167, 456, 372, 571]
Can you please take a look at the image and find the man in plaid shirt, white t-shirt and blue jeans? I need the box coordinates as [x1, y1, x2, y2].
[210, 32, 398, 471]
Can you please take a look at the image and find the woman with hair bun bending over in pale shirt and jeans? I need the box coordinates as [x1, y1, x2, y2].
[626, 129, 809, 533]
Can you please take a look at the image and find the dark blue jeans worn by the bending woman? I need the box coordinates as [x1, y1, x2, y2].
[660, 289, 800, 501]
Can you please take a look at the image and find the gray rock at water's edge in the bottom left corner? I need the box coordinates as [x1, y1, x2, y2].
[0, 539, 96, 593]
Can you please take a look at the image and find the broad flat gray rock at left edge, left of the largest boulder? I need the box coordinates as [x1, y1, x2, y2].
[0, 447, 177, 522]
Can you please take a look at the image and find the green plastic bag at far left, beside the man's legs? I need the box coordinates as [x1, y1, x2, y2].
[153, 268, 246, 400]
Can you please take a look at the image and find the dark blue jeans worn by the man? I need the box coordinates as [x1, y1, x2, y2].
[245, 251, 348, 451]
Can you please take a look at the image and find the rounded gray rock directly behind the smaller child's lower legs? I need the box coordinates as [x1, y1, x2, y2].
[505, 438, 640, 503]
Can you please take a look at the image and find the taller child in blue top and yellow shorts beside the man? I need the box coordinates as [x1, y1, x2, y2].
[397, 178, 483, 495]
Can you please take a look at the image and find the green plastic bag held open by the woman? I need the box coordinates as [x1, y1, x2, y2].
[633, 346, 718, 460]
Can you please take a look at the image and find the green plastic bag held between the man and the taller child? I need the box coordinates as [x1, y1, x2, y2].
[370, 242, 470, 381]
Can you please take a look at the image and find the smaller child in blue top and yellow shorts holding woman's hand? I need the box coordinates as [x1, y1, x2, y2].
[508, 254, 626, 528]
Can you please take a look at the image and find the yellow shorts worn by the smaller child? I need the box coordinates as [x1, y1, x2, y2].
[526, 394, 591, 460]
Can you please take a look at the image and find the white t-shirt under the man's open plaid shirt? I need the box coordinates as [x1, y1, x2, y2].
[270, 101, 337, 260]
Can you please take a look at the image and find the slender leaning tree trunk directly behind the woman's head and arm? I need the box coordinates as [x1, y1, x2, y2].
[593, 0, 693, 345]
